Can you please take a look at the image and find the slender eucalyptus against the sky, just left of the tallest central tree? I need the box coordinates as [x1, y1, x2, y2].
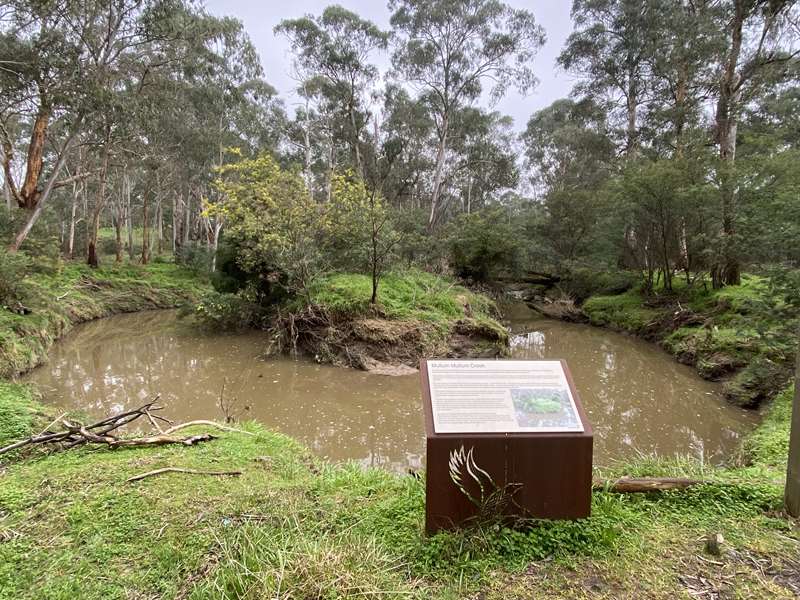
[275, 5, 389, 180]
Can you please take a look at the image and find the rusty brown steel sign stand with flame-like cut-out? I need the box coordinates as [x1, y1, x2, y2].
[420, 360, 593, 533]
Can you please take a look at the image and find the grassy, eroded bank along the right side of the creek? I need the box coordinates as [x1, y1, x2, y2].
[581, 276, 800, 407]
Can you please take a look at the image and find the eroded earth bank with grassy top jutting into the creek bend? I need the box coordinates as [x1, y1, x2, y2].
[271, 271, 508, 375]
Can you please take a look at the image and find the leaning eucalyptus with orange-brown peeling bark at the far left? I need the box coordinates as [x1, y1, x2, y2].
[0, 0, 216, 251]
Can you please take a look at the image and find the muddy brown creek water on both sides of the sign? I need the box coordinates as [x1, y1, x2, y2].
[25, 304, 757, 471]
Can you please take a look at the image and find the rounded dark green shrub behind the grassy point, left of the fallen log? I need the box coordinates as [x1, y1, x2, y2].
[446, 206, 524, 282]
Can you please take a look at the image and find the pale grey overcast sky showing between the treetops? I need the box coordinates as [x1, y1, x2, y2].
[206, 0, 572, 129]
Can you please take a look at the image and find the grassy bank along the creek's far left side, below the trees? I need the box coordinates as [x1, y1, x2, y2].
[0, 263, 207, 378]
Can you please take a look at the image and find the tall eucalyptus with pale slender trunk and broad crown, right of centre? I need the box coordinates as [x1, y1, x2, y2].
[389, 0, 545, 229]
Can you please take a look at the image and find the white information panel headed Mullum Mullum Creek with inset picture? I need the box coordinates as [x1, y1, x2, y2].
[427, 360, 583, 433]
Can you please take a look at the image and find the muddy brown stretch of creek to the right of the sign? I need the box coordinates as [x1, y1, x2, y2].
[506, 304, 757, 464]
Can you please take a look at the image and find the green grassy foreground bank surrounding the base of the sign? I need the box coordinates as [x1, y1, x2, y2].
[0, 384, 800, 600]
